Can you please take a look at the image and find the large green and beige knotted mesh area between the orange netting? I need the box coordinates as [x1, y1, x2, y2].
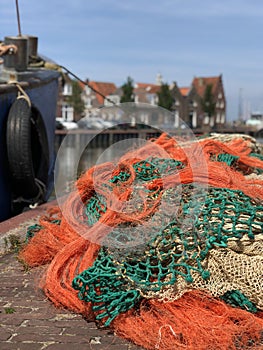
[73, 185, 263, 324]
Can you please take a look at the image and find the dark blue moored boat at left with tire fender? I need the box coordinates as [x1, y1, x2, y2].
[0, 35, 59, 221]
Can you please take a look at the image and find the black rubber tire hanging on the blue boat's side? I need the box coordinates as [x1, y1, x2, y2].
[6, 98, 49, 202]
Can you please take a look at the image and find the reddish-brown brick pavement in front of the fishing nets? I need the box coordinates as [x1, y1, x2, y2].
[0, 252, 142, 350]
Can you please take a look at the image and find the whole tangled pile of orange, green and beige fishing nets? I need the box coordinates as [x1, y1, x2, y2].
[20, 134, 263, 350]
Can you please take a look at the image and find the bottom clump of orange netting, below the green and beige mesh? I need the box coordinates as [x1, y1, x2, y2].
[112, 291, 263, 350]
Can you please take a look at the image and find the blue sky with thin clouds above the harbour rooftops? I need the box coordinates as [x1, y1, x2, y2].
[0, 0, 263, 120]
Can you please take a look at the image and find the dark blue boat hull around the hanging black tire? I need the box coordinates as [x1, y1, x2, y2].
[0, 70, 59, 221]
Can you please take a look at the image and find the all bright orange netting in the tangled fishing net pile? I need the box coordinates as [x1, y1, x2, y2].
[20, 134, 263, 350]
